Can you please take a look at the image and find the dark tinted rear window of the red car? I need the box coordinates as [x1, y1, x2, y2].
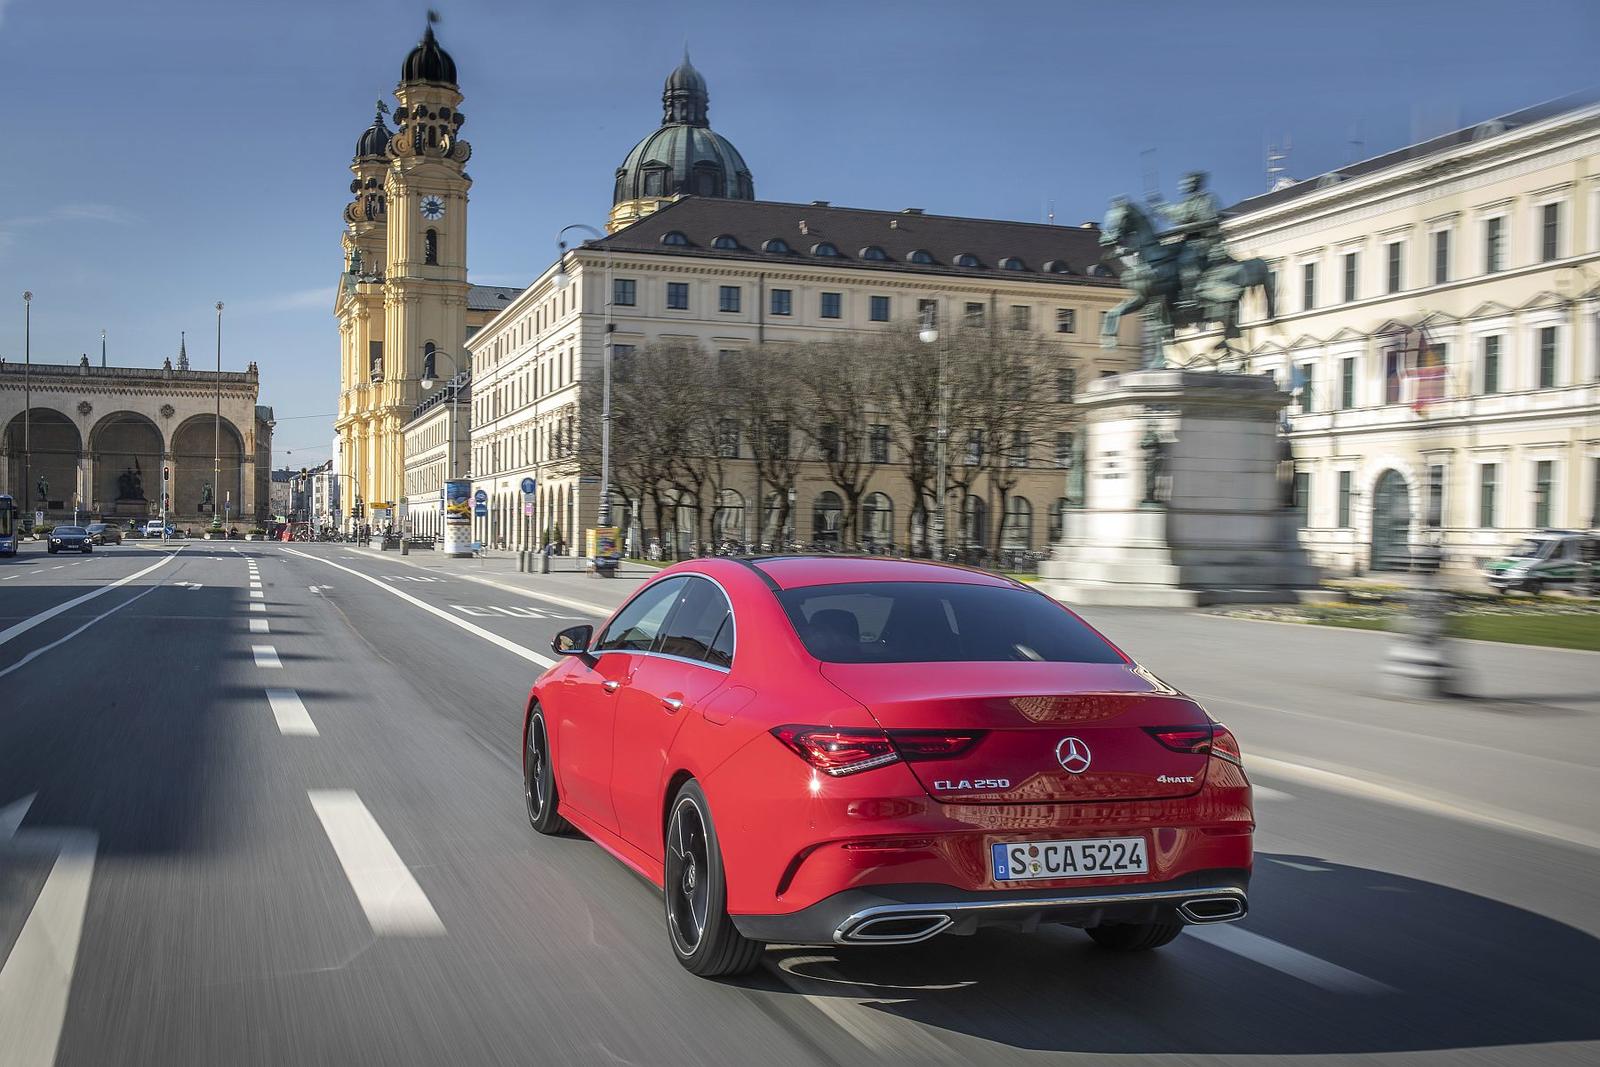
[778, 582, 1126, 664]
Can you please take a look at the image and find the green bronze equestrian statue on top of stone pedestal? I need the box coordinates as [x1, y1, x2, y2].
[1101, 171, 1277, 370]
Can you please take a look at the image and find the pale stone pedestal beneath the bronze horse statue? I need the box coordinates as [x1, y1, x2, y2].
[1038, 370, 1318, 608]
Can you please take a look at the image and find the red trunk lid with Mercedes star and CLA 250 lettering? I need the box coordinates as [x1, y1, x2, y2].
[822, 662, 1211, 805]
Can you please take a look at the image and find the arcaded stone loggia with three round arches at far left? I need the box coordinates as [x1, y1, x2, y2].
[0, 354, 272, 525]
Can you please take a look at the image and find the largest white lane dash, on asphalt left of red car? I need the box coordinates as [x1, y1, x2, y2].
[307, 789, 445, 934]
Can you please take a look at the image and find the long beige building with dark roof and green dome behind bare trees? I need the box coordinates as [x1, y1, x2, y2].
[469, 59, 1138, 552]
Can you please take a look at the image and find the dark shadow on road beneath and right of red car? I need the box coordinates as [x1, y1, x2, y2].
[770, 854, 1600, 1056]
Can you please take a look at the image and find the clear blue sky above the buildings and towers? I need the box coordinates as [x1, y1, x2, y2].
[0, 0, 1600, 467]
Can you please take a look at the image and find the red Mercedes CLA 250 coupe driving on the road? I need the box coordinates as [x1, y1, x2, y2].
[523, 557, 1254, 976]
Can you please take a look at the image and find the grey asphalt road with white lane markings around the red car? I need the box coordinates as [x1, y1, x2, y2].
[0, 542, 1600, 1067]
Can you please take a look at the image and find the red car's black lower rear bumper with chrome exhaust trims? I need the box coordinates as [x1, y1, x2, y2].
[733, 869, 1250, 945]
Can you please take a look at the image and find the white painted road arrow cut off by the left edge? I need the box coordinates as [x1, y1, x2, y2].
[0, 793, 99, 1067]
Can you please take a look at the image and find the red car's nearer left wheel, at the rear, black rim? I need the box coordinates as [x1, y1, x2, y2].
[661, 781, 766, 977]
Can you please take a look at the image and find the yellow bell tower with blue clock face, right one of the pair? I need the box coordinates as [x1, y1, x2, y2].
[377, 13, 472, 502]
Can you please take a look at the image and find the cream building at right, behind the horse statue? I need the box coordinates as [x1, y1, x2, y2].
[1170, 101, 1600, 569]
